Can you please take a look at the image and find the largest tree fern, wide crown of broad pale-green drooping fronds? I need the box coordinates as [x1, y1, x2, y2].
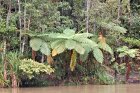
[28, 29, 113, 69]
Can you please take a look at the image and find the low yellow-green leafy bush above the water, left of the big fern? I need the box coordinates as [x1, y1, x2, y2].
[19, 59, 54, 79]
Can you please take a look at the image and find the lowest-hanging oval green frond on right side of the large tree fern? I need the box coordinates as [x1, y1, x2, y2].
[93, 48, 104, 63]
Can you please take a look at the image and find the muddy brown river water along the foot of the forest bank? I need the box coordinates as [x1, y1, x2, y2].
[0, 84, 140, 93]
